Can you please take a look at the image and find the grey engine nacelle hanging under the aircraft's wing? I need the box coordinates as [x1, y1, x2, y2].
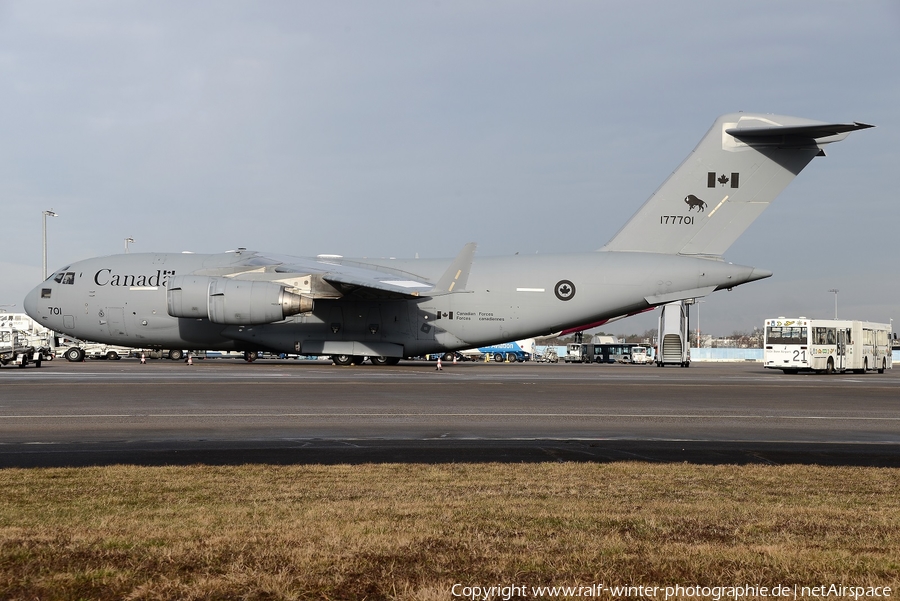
[166, 275, 313, 325]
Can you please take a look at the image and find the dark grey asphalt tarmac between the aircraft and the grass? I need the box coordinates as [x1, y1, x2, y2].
[0, 359, 900, 467]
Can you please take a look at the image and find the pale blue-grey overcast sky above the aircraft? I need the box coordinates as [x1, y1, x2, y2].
[0, 0, 900, 334]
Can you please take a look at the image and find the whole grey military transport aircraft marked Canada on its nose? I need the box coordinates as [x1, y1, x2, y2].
[24, 113, 872, 365]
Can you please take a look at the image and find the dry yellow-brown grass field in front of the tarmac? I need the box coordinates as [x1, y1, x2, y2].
[0, 463, 900, 600]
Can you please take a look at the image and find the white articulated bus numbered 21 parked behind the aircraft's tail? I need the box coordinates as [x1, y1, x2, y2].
[763, 317, 892, 374]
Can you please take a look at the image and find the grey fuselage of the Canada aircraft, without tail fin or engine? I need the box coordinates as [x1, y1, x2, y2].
[25, 251, 771, 357]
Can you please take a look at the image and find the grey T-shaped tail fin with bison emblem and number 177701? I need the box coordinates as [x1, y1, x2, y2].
[601, 113, 873, 256]
